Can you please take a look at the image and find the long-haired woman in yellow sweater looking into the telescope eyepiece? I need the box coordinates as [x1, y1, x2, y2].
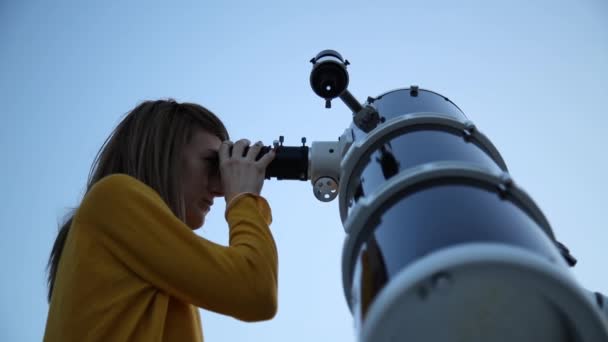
[44, 100, 277, 342]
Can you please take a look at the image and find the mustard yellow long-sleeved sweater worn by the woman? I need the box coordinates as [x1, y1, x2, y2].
[44, 175, 277, 342]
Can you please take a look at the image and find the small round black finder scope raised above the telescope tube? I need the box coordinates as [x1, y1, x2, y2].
[310, 50, 348, 100]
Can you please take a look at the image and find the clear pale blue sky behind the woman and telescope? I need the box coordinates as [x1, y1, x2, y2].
[0, 0, 608, 342]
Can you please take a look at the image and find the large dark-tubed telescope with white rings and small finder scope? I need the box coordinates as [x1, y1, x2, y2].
[261, 50, 608, 342]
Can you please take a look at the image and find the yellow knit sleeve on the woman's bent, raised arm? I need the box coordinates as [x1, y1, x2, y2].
[74, 175, 278, 321]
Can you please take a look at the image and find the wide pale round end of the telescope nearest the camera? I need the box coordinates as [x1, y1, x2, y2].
[355, 243, 608, 342]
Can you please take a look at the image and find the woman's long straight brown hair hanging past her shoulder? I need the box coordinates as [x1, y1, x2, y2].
[47, 99, 229, 302]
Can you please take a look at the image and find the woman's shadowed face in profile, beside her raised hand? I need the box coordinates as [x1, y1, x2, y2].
[180, 129, 223, 229]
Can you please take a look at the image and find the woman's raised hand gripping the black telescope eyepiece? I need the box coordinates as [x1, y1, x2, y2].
[218, 139, 275, 203]
